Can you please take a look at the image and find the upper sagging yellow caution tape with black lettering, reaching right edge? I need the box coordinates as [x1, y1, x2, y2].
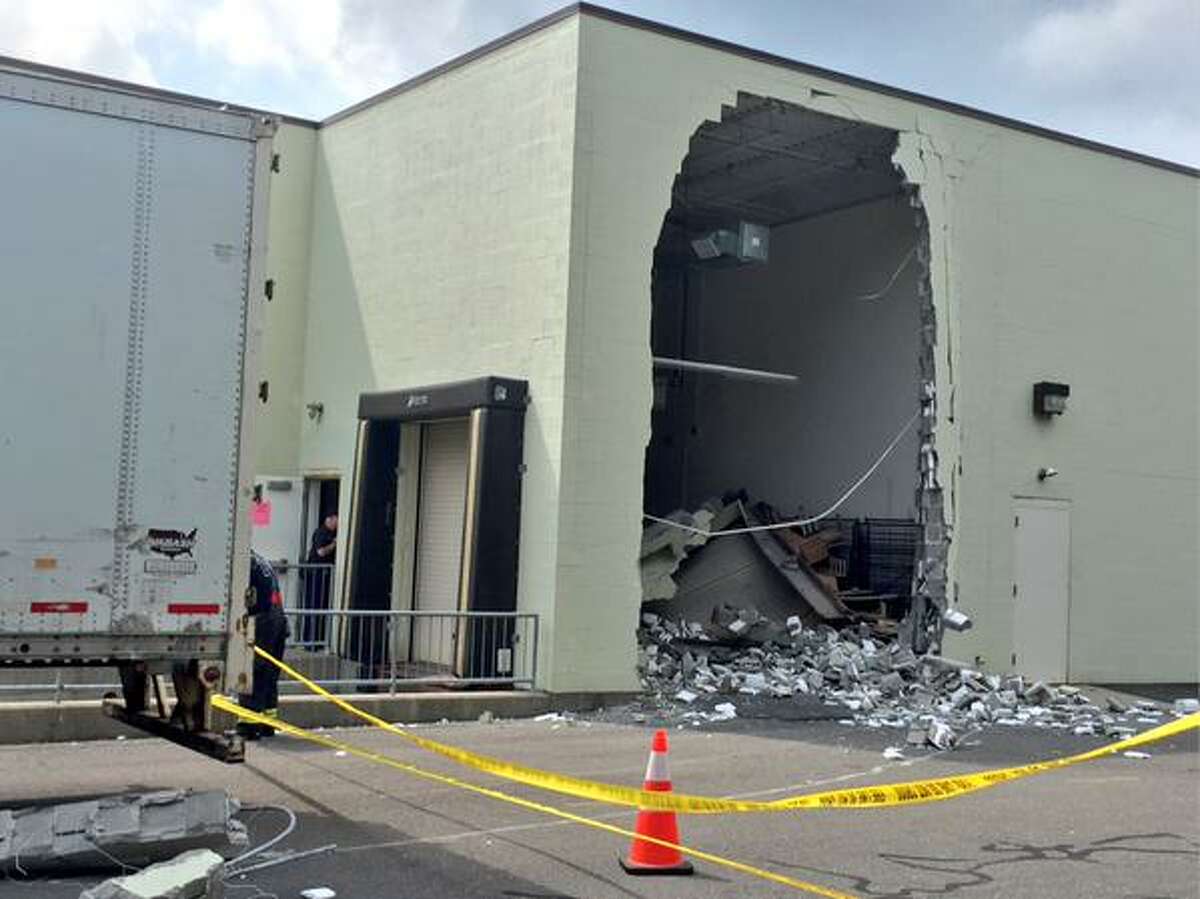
[236, 647, 1200, 815]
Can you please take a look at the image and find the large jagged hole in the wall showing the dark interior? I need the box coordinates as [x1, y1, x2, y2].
[643, 94, 944, 648]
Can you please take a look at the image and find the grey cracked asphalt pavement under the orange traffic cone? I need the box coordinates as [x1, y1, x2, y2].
[0, 705, 1200, 899]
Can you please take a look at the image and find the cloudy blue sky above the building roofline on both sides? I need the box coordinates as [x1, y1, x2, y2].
[0, 0, 1200, 167]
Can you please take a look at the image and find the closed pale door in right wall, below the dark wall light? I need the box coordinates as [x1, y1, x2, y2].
[1013, 498, 1070, 683]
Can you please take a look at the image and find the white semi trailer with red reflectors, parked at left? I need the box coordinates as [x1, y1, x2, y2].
[0, 61, 275, 761]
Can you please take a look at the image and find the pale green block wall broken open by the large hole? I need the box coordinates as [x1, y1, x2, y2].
[558, 7, 1198, 681]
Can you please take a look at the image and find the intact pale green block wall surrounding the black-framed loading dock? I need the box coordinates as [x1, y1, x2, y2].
[300, 18, 583, 689]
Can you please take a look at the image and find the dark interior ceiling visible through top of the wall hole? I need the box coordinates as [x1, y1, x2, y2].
[660, 94, 901, 257]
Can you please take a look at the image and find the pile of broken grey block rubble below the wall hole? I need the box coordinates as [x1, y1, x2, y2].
[638, 605, 1164, 749]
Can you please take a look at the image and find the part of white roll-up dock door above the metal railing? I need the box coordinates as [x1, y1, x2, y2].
[414, 419, 470, 611]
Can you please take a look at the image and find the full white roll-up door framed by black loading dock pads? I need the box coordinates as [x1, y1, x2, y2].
[413, 419, 470, 666]
